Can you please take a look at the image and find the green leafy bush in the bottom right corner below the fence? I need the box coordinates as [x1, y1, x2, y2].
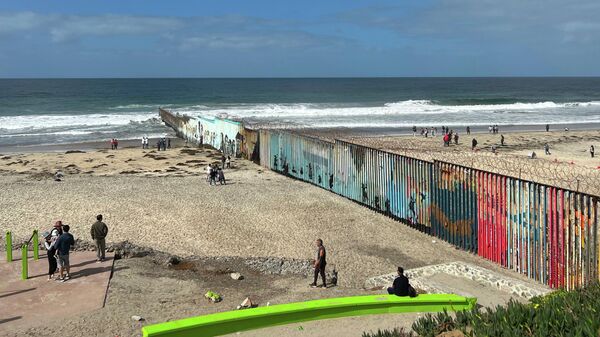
[363, 283, 600, 337]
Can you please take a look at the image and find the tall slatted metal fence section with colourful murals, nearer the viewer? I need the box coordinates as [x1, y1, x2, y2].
[161, 109, 600, 289]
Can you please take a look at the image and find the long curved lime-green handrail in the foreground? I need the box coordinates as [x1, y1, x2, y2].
[142, 294, 477, 337]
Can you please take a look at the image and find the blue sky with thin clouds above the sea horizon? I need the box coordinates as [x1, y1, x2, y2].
[0, 0, 600, 78]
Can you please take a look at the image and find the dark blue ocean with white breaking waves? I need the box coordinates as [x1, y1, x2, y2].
[0, 77, 600, 146]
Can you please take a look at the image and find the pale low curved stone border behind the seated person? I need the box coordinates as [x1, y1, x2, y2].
[365, 261, 552, 299]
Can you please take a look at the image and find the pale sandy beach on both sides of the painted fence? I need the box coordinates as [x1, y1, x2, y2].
[0, 131, 600, 336]
